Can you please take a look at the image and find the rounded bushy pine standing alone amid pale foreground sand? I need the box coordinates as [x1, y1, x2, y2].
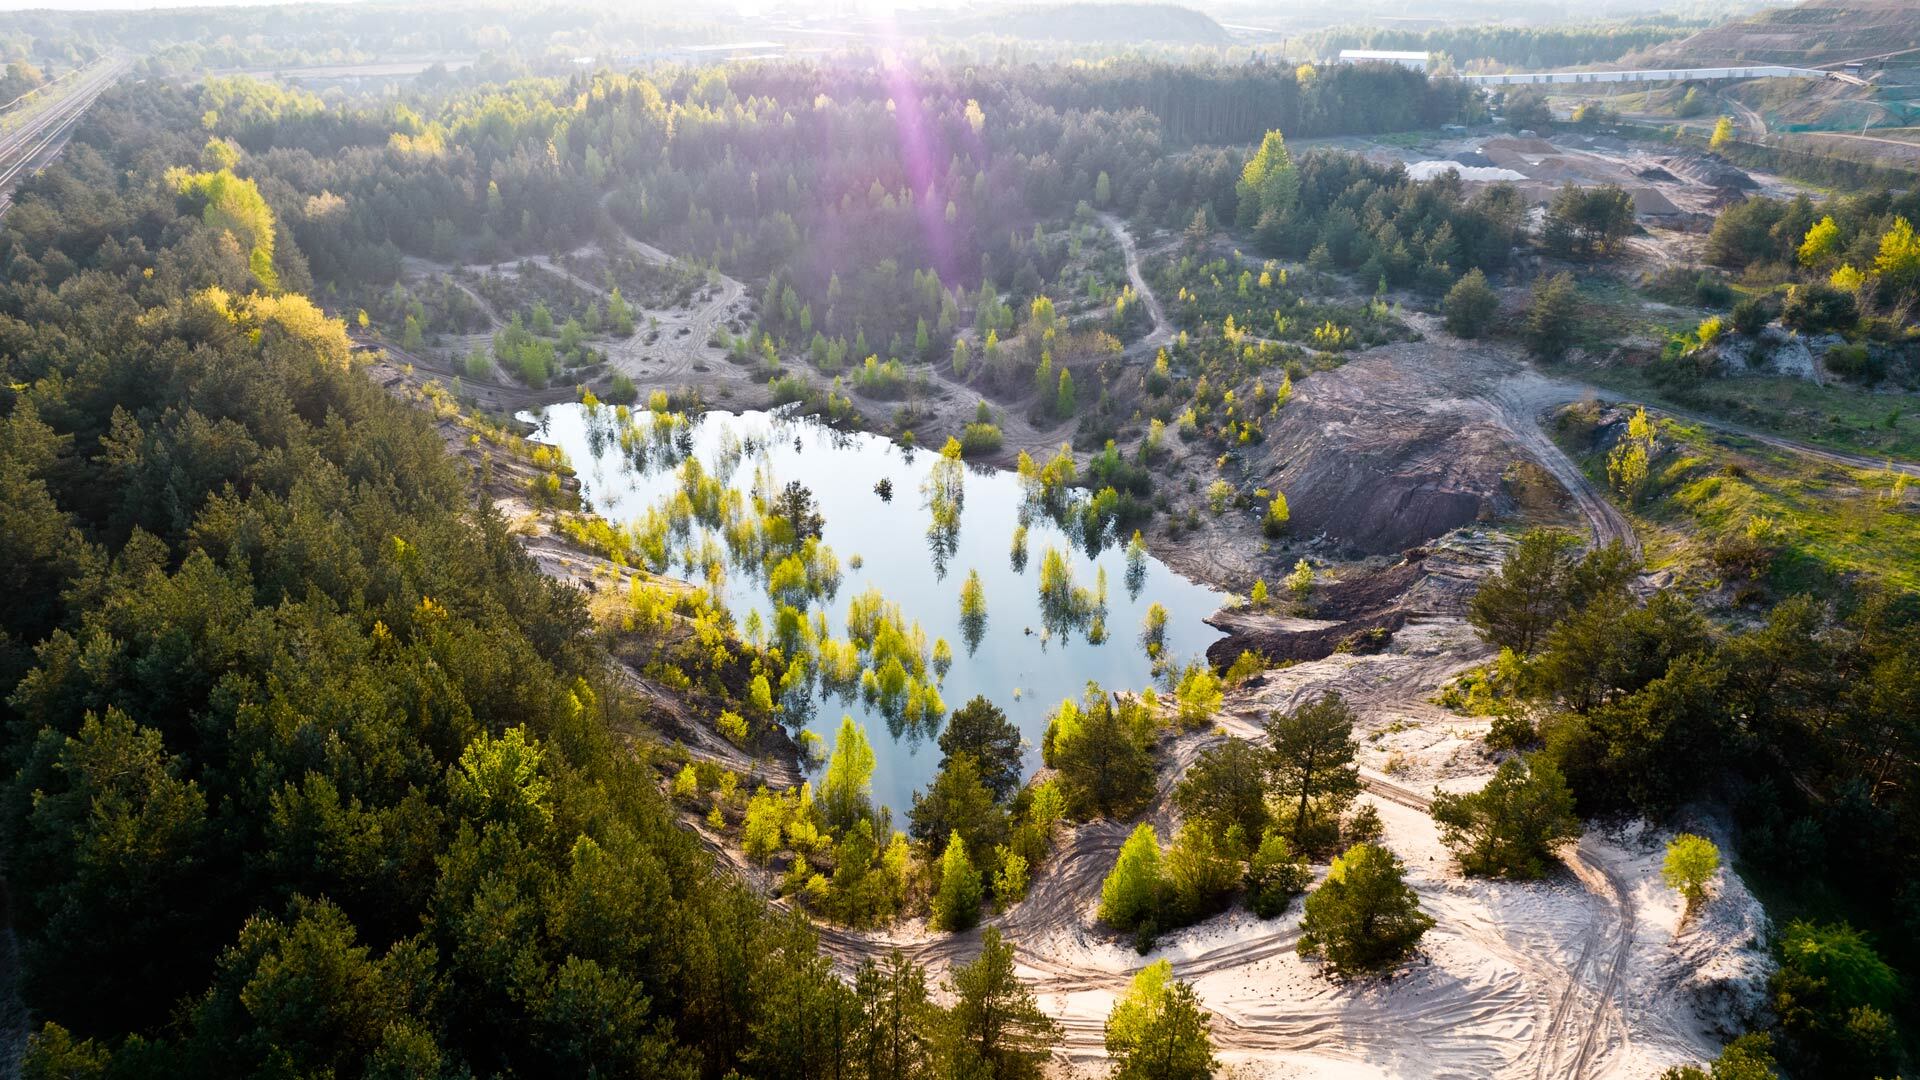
[1300, 844, 1434, 976]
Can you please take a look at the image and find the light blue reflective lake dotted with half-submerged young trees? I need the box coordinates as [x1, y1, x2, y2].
[520, 404, 1229, 814]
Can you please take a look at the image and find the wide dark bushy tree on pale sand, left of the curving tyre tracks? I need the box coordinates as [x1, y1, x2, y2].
[1432, 755, 1580, 880]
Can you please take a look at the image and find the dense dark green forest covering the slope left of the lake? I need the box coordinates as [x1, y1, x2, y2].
[0, 71, 1128, 1078]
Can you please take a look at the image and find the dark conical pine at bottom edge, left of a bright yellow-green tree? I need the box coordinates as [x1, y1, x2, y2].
[941, 926, 1060, 1080]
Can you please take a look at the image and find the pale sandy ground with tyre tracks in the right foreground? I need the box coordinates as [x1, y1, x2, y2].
[779, 595, 1768, 1080]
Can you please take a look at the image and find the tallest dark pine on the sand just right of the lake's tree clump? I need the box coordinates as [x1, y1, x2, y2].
[1265, 690, 1359, 851]
